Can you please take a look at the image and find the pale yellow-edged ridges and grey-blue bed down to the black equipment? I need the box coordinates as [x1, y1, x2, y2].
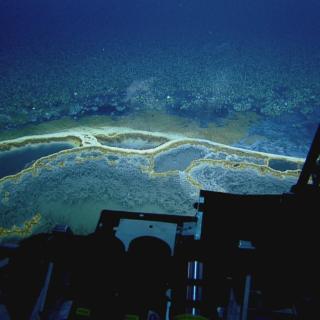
[0, 127, 303, 241]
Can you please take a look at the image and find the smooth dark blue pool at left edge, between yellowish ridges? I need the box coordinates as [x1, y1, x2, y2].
[0, 143, 73, 179]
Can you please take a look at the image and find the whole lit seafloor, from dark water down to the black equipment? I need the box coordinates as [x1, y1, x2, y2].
[0, 37, 320, 241]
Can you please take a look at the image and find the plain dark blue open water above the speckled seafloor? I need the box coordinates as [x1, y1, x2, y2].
[0, 0, 320, 45]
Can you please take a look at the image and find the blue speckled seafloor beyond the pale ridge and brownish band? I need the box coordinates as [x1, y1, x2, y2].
[0, 35, 320, 157]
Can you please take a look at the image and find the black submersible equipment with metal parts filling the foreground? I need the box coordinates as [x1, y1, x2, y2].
[0, 127, 320, 320]
